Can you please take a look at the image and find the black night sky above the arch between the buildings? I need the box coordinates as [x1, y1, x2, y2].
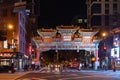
[39, 0, 86, 26]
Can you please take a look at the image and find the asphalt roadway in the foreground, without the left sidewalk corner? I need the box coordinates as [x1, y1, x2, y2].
[16, 70, 120, 80]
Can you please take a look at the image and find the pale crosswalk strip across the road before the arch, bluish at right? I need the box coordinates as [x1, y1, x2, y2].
[40, 69, 120, 77]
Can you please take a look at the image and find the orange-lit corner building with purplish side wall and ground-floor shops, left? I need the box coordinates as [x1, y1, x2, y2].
[0, 0, 26, 70]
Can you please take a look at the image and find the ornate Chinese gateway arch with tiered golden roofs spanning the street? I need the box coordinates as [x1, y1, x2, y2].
[33, 25, 100, 69]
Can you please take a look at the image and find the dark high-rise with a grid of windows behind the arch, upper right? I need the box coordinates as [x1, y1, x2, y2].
[86, 0, 120, 29]
